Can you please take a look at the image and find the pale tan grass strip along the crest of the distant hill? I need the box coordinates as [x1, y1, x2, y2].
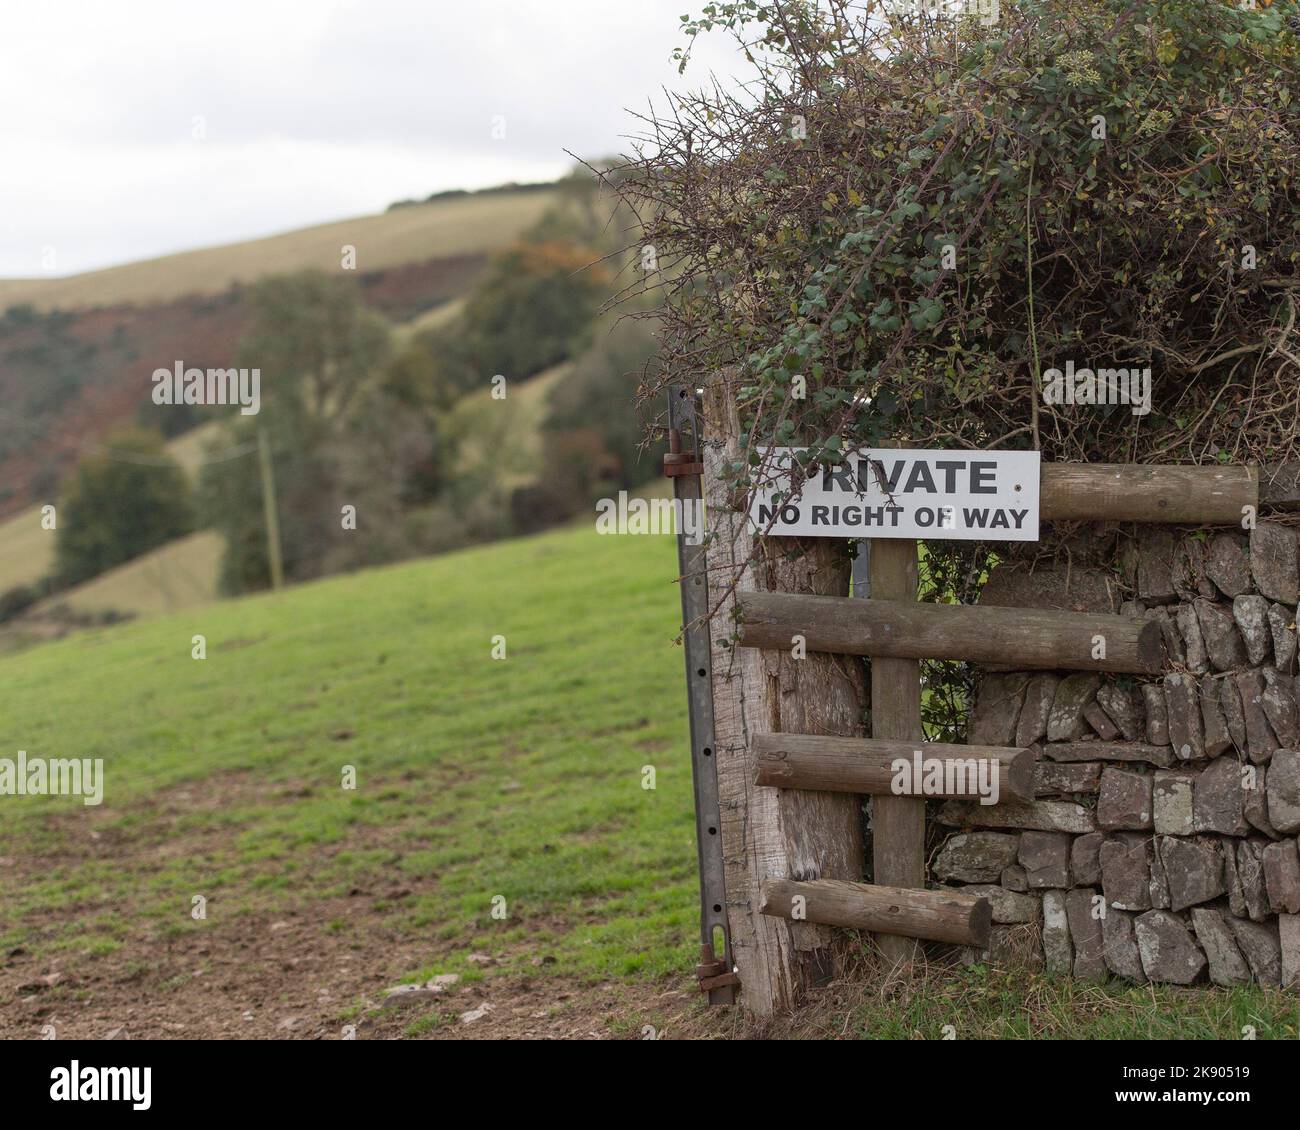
[0, 191, 555, 309]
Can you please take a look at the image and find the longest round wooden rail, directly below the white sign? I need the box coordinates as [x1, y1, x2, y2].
[737, 593, 1165, 675]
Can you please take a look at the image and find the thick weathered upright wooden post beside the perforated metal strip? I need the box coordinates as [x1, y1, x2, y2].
[702, 377, 866, 1016]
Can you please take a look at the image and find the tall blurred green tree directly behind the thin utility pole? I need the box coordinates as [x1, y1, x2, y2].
[199, 270, 416, 593]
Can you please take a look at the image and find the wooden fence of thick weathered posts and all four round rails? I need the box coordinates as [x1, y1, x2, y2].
[670, 380, 1300, 1016]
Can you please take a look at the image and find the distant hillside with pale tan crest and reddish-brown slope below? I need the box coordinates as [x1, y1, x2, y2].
[0, 190, 554, 518]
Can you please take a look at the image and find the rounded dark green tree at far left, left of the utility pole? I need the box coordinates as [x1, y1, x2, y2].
[55, 430, 194, 585]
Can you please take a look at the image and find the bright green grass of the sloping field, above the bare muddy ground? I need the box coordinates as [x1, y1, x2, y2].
[0, 528, 696, 978]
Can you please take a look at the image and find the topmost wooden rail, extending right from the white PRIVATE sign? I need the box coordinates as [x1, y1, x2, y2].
[1039, 463, 1260, 525]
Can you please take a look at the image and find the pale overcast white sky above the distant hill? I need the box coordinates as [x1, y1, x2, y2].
[0, 0, 742, 277]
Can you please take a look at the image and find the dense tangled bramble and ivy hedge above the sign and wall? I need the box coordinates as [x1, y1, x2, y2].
[624, 0, 1300, 479]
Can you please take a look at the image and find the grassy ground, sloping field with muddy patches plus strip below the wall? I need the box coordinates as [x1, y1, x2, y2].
[0, 523, 1297, 1038]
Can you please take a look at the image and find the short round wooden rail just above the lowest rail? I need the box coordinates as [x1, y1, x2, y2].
[754, 733, 1034, 801]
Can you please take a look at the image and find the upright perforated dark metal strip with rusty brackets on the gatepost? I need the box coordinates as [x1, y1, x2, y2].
[663, 386, 740, 1004]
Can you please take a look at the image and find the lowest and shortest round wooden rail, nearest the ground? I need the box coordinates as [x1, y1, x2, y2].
[758, 879, 993, 947]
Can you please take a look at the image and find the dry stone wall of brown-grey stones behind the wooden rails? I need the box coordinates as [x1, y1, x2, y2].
[931, 521, 1300, 986]
